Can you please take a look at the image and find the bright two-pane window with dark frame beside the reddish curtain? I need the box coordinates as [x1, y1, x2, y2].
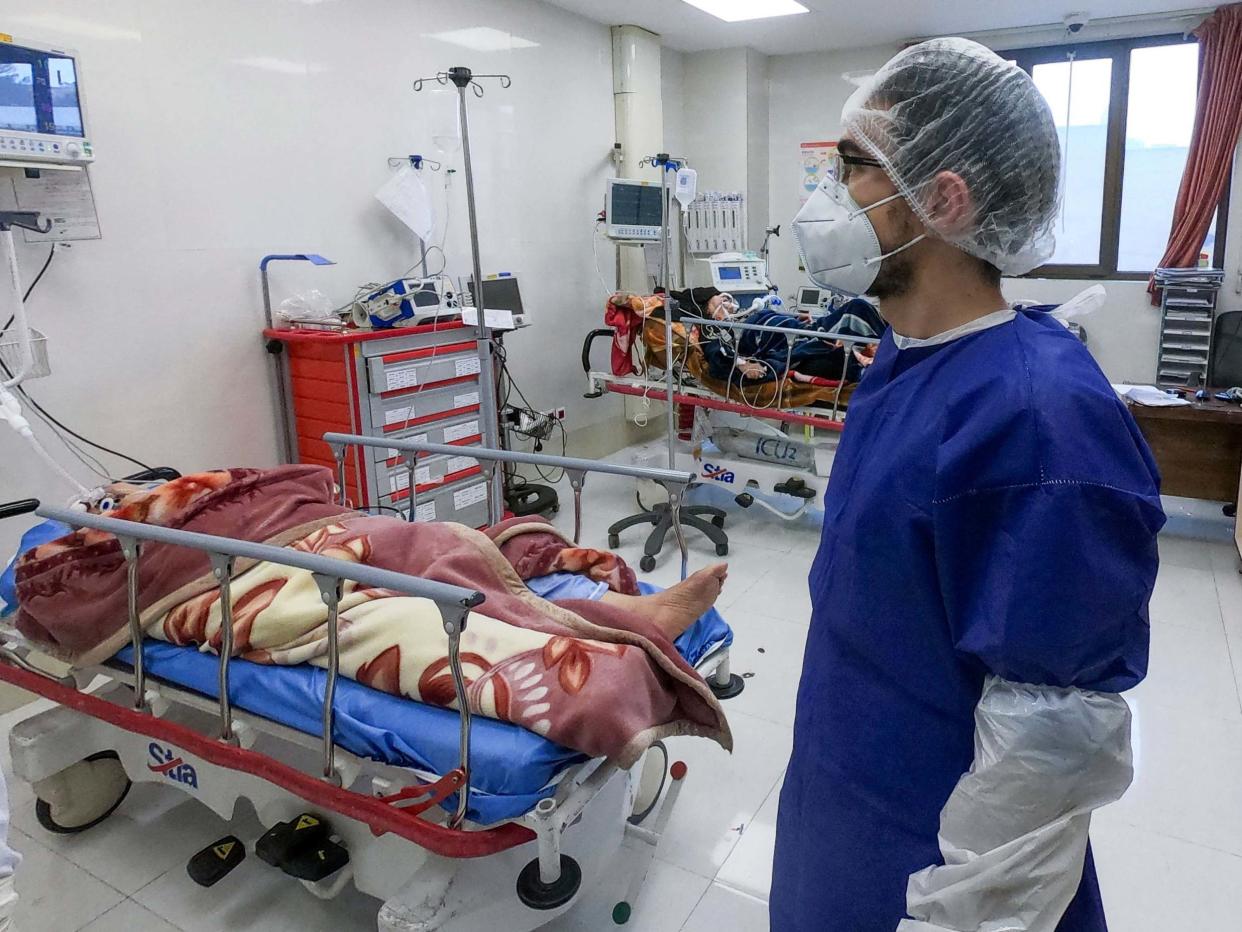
[1006, 36, 1228, 278]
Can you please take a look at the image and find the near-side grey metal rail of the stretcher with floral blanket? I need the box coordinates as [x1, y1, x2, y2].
[35, 506, 484, 828]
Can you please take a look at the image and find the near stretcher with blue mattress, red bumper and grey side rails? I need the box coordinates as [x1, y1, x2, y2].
[0, 435, 735, 932]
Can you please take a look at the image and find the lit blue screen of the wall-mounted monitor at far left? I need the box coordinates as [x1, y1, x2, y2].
[0, 42, 83, 137]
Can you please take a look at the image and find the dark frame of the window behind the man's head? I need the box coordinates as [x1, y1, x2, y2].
[997, 32, 1232, 281]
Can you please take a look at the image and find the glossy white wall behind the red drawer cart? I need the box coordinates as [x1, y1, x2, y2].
[0, 0, 620, 554]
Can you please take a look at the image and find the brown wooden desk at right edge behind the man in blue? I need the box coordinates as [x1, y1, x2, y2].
[1126, 399, 1242, 553]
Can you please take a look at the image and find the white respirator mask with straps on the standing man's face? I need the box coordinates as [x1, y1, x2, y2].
[794, 178, 927, 296]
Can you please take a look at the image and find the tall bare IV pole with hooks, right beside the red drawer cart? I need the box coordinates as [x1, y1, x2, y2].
[411, 67, 513, 524]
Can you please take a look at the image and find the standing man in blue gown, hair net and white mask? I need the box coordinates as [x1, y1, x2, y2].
[771, 39, 1164, 932]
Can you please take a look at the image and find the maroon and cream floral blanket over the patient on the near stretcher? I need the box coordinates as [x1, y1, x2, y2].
[16, 466, 732, 765]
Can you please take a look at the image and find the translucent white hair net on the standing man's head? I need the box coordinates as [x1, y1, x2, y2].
[841, 39, 1061, 275]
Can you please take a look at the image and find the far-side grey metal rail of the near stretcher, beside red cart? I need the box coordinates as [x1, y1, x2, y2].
[323, 434, 694, 579]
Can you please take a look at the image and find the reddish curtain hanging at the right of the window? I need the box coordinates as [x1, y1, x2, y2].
[1148, 4, 1242, 304]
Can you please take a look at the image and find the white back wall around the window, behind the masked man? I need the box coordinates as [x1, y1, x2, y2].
[769, 46, 1242, 381]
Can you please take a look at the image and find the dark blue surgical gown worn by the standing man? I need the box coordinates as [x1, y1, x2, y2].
[771, 312, 1164, 932]
